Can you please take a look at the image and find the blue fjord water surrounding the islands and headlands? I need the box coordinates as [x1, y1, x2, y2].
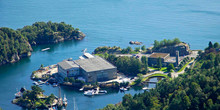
[0, 0, 220, 110]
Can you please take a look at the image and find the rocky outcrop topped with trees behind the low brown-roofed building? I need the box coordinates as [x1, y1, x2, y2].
[153, 43, 191, 56]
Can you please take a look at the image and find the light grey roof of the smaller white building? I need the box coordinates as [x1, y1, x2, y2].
[57, 60, 79, 70]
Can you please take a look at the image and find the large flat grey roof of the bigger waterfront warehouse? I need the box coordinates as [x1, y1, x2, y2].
[74, 56, 116, 72]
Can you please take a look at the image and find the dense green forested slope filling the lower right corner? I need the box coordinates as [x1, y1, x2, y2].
[103, 43, 220, 110]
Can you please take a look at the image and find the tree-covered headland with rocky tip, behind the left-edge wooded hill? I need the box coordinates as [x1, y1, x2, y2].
[18, 21, 85, 45]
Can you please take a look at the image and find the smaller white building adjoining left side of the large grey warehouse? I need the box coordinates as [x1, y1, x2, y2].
[57, 60, 79, 78]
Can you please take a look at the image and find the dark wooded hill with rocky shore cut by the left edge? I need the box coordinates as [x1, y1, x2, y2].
[0, 28, 32, 65]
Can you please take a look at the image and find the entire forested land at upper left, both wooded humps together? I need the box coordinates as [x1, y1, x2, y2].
[0, 21, 85, 66]
